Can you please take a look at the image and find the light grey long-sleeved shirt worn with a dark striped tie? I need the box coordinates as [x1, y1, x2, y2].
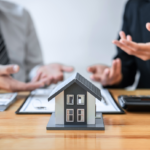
[0, 0, 43, 81]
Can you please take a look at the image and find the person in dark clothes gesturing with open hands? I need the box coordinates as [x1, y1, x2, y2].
[88, 0, 150, 88]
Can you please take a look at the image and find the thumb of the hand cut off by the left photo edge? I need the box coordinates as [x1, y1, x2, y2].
[0, 65, 19, 75]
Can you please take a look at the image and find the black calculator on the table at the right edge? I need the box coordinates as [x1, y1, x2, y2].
[118, 95, 150, 111]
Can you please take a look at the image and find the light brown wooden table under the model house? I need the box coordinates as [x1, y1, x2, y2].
[0, 90, 150, 150]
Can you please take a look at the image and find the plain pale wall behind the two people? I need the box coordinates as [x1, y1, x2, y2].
[5, 0, 127, 86]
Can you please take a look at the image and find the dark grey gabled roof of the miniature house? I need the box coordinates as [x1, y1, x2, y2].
[48, 73, 101, 101]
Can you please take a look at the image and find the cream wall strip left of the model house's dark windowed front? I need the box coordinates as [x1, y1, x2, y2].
[55, 91, 64, 124]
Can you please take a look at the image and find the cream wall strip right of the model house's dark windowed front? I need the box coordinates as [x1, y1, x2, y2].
[87, 92, 96, 124]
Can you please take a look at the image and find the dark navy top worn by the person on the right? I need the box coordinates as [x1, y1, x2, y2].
[115, 0, 150, 88]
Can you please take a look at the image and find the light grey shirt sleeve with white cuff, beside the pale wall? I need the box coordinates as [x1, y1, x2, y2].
[25, 11, 43, 81]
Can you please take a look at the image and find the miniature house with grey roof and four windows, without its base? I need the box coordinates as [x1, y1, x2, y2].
[48, 73, 104, 130]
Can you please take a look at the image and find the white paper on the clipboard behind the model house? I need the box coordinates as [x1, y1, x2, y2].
[19, 88, 121, 113]
